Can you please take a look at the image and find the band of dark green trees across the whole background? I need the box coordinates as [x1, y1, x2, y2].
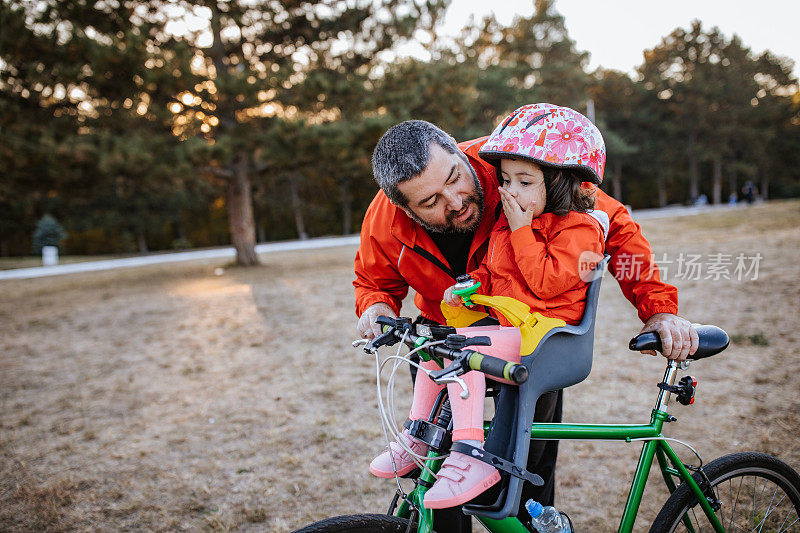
[0, 0, 800, 255]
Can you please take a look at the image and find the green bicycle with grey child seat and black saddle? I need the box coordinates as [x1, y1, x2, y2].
[297, 265, 800, 533]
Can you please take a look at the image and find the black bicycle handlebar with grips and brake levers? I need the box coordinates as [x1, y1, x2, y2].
[364, 317, 528, 384]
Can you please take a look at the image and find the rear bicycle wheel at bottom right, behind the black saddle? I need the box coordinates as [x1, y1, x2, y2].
[650, 452, 800, 533]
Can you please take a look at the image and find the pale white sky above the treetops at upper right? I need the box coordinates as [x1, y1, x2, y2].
[441, 0, 800, 77]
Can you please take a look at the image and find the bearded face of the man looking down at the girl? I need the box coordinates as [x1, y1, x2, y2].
[397, 144, 483, 233]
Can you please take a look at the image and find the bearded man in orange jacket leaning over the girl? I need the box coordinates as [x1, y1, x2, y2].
[353, 120, 698, 531]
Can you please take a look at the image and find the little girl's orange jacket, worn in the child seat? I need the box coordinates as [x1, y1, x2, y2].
[470, 211, 604, 326]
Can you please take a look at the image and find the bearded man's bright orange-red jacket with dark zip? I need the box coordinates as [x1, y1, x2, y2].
[353, 137, 678, 323]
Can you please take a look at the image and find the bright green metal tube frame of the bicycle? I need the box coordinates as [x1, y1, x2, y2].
[397, 363, 725, 533]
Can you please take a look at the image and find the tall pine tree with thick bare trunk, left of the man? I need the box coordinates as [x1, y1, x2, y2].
[176, 0, 443, 265]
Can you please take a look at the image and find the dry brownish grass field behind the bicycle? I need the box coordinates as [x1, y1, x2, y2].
[0, 201, 800, 532]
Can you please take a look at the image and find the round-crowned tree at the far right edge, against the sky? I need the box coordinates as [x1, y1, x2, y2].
[639, 21, 797, 202]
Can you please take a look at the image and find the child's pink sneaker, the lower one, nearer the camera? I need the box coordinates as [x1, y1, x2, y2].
[422, 452, 500, 509]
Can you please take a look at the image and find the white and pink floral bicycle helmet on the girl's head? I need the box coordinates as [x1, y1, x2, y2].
[478, 103, 606, 184]
